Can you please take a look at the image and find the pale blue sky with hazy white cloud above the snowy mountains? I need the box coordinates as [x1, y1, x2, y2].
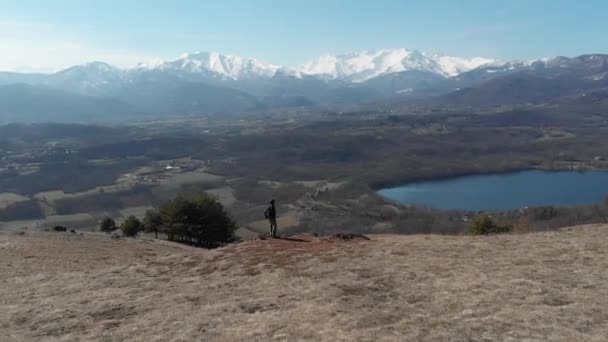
[0, 0, 608, 72]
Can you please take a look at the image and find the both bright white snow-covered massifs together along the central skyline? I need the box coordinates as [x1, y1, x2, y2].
[135, 49, 501, 83]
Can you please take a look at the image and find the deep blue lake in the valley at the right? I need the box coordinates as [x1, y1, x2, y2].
[378, 170, 608, 211]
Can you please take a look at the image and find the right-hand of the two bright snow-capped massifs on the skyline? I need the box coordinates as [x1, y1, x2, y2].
[298, 49, 500, 82]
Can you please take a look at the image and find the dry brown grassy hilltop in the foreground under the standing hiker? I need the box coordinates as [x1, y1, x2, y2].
[0, 225, 608, 341]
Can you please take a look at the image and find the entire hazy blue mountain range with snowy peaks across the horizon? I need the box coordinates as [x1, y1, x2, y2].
[0, 49, 608, 122]
